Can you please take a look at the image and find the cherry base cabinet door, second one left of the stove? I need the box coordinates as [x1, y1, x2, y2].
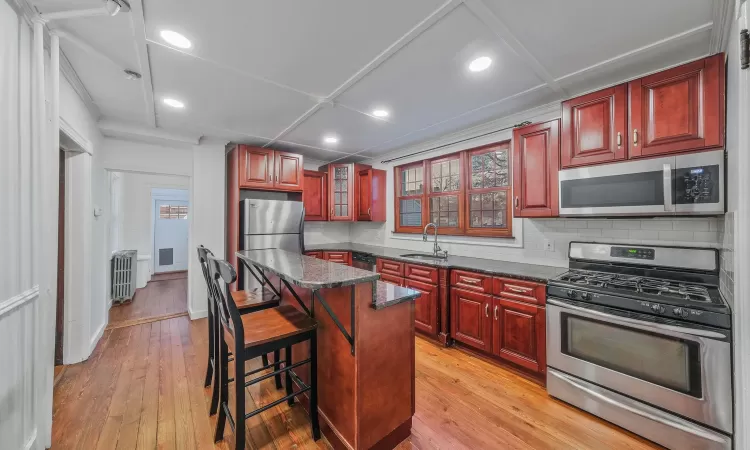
[452, 285, 492, 352]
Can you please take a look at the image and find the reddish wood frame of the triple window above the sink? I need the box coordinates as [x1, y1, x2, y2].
[393, 140, 514, 239]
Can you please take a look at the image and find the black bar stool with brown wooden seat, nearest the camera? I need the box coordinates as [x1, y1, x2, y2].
[208, 256, 320, 449]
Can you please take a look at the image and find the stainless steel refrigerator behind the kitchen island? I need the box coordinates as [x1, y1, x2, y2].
[238, 199, 305, 289]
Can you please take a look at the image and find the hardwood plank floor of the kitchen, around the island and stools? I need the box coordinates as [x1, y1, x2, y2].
[52, 317, 658, 450]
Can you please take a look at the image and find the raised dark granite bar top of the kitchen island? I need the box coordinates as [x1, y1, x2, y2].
[237, 249, 380, 290]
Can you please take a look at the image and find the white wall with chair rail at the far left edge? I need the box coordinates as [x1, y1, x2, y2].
[0, 2, 40, 450]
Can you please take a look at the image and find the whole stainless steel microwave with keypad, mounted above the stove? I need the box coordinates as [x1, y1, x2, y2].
[559, 150, 726, 217]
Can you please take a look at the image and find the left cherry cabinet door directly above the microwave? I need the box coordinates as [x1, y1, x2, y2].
[560, 84, 628, 169]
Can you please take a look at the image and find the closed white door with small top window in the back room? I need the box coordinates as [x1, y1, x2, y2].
[154, 199, 190, 273]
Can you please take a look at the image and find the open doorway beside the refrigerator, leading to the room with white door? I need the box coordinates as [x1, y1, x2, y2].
[107, 171, 191, 329]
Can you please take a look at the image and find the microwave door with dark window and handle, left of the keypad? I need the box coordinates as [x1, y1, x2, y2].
[559, 157, 675, 216]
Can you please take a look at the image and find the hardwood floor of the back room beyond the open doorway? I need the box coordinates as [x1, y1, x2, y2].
[107, 272, 187, 329]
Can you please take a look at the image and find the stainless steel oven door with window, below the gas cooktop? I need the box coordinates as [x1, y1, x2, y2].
[547, 298, 732, 434]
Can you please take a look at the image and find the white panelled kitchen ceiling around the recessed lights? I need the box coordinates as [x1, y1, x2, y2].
[34, 0, 732, 161]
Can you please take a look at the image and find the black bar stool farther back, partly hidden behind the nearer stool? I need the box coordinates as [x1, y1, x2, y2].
[198, 245, 282, 416]
